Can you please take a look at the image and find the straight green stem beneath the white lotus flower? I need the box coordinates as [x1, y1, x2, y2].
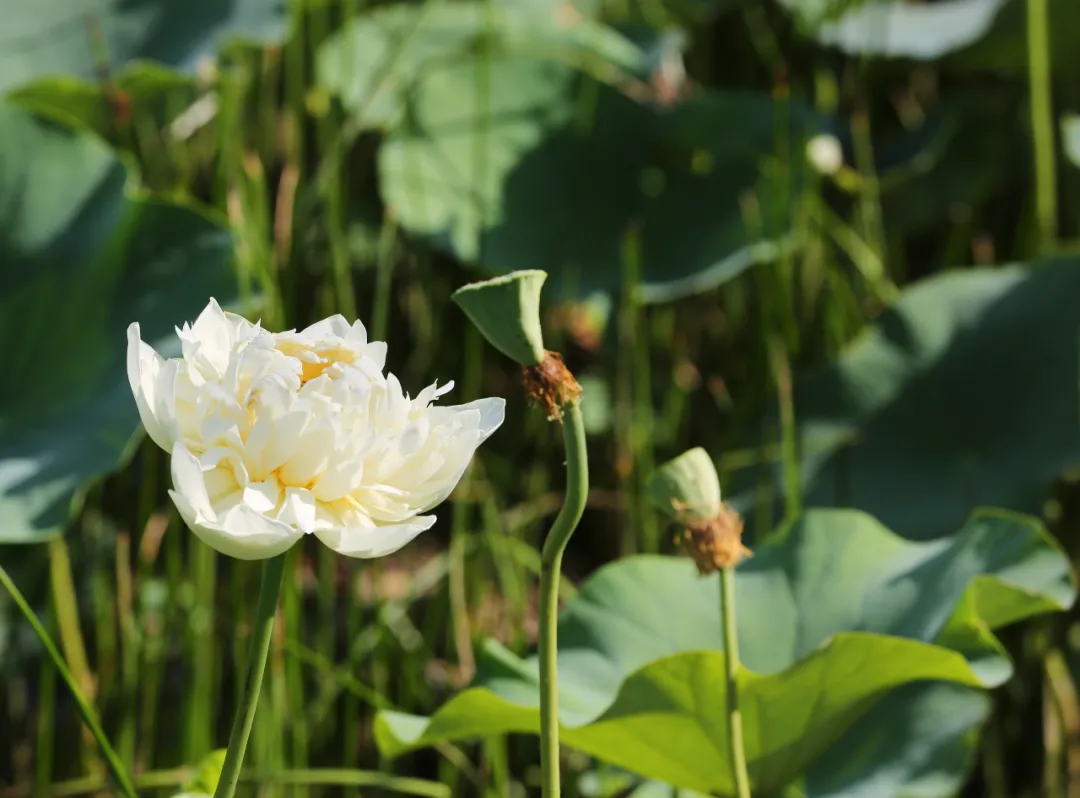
[214, 554, 286, 798]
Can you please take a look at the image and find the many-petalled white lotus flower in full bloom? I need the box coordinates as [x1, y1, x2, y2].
[127, 300, 504, 559]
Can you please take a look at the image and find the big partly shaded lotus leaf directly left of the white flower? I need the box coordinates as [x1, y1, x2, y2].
[0, 106, 237, 542]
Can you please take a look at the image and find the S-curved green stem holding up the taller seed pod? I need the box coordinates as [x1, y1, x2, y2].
[539, 403, 589, 798]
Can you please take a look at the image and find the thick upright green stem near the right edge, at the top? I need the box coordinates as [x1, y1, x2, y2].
[1027, 0, 1057, 253]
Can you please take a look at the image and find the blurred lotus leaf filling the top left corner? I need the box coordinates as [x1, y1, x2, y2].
[0, 0, 286, 92]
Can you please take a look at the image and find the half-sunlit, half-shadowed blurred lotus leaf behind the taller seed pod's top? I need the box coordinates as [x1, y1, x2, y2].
[379, 56, 810, 301]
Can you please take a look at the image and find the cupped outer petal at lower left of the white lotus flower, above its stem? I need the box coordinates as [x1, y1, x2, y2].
[168, 444, 303, 559]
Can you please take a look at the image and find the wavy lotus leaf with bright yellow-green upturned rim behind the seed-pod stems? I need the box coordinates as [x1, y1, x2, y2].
[376, 511, 1075, 793]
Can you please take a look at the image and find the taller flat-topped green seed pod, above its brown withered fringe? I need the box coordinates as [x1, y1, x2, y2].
[451, 269, 548, 367]
